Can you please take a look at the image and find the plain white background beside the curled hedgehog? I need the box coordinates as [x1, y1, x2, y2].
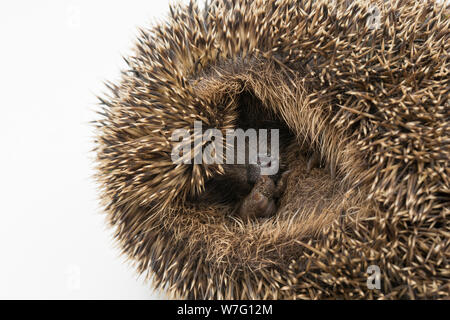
[0, 0, 187, 299]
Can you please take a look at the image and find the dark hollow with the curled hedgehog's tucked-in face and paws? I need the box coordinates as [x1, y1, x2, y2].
[200, 88, 343, 219]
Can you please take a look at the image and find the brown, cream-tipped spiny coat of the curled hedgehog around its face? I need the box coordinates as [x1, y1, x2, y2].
[96, 0, 450, 299]
